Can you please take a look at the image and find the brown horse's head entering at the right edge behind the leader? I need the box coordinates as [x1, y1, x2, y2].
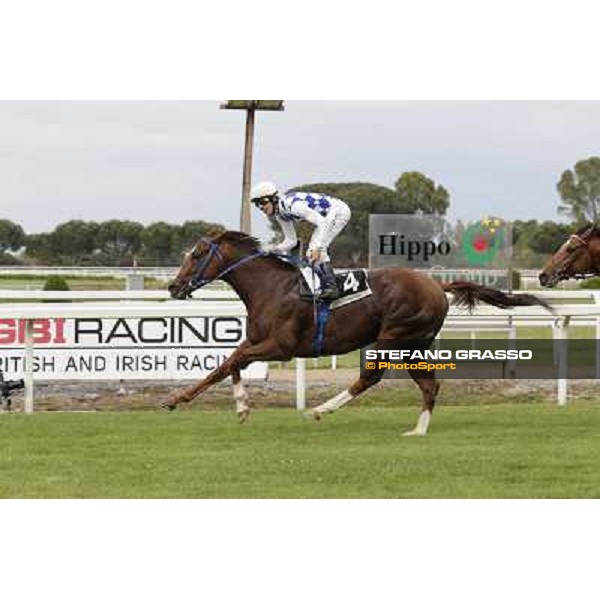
[539, 223, 600, 287]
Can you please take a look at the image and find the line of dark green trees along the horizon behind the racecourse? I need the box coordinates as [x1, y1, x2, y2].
[0, 157, 600, 268]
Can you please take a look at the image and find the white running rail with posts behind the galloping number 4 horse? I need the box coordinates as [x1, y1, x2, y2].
[0, 289, 600, 412]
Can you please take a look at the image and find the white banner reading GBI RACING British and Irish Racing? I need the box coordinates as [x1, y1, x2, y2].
[0, 316, 266, 380]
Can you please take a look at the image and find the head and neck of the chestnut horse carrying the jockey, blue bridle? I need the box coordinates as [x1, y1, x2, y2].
[168, 231, 263, 300]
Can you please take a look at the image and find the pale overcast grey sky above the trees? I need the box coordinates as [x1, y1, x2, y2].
[0, 101, 600, 235]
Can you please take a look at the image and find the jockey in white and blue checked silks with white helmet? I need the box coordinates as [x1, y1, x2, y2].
[250, 181, 351, 301]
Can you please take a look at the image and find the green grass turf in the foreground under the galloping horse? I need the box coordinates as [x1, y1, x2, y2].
[0, 403, 600, 498]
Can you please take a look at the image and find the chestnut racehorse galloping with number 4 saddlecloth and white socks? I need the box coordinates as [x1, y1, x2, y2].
[163, 231, 545, 435]
